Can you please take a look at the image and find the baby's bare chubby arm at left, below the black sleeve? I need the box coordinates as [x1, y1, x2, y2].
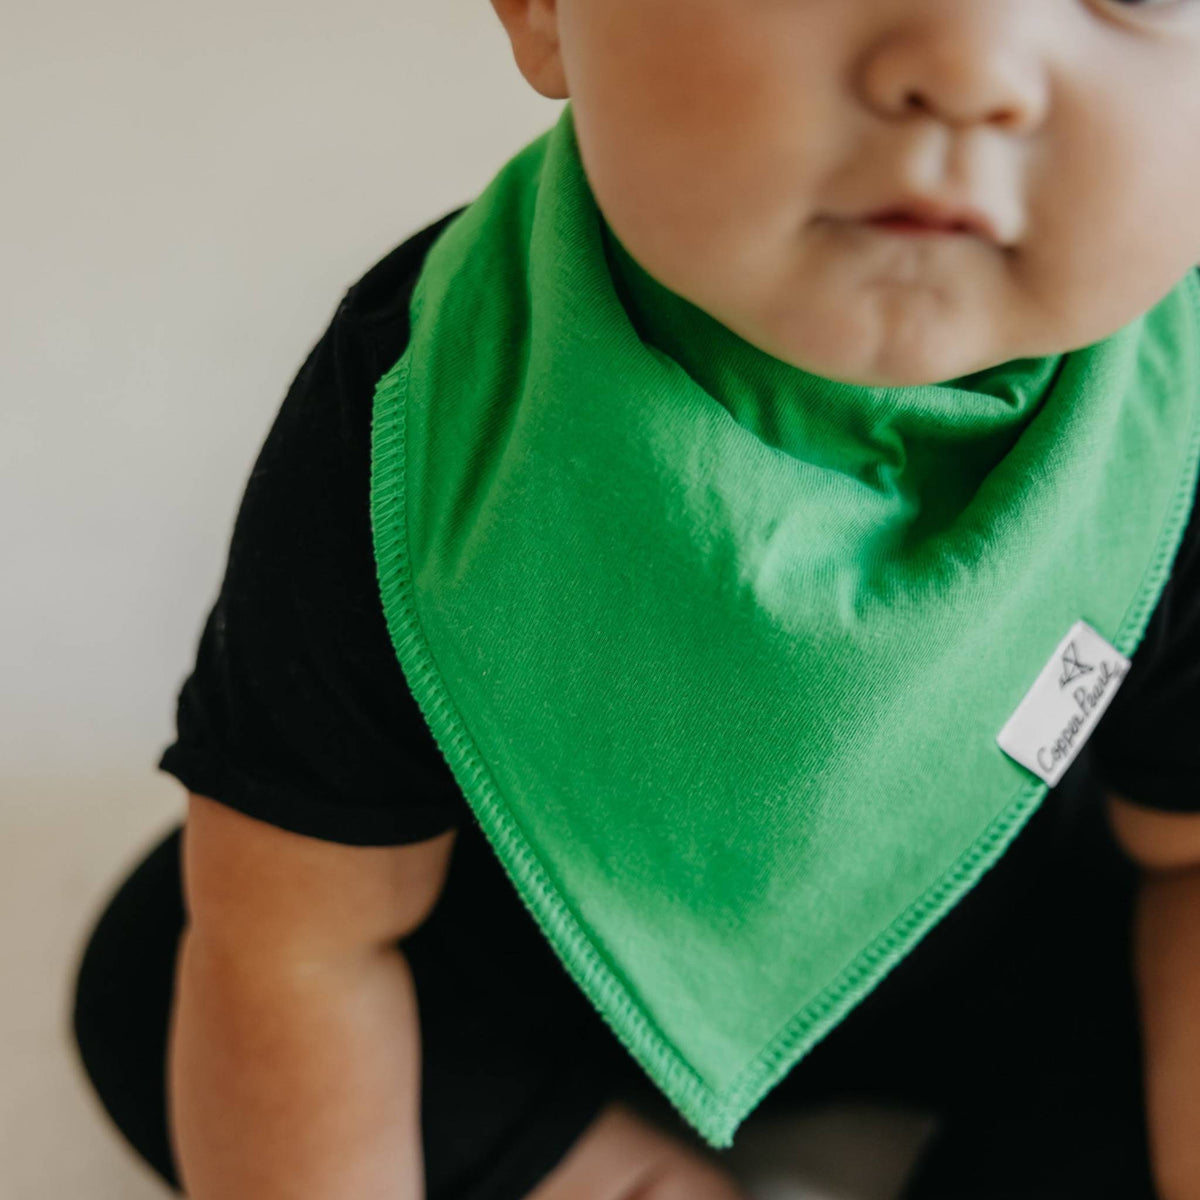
[168, 793, 455, 1200]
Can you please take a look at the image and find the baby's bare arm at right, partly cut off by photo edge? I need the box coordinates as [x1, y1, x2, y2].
[1109, 796, 1200, 1200]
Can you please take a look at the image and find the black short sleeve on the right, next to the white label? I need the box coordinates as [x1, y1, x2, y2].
[1090, 472, 1200, 812]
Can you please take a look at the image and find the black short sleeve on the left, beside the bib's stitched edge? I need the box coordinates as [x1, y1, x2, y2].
[157, 214, 470, 845]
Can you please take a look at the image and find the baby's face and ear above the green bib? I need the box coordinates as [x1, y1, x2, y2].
[492, 0, 1200, 384]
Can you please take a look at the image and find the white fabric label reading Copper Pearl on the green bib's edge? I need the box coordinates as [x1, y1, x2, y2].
[996, 620, 1130, 787]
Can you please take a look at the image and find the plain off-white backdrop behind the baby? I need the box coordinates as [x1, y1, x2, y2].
[0, 0, 930, 1200]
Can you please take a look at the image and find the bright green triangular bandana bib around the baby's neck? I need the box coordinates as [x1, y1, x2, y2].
[371, 103, 1200, 1147]
